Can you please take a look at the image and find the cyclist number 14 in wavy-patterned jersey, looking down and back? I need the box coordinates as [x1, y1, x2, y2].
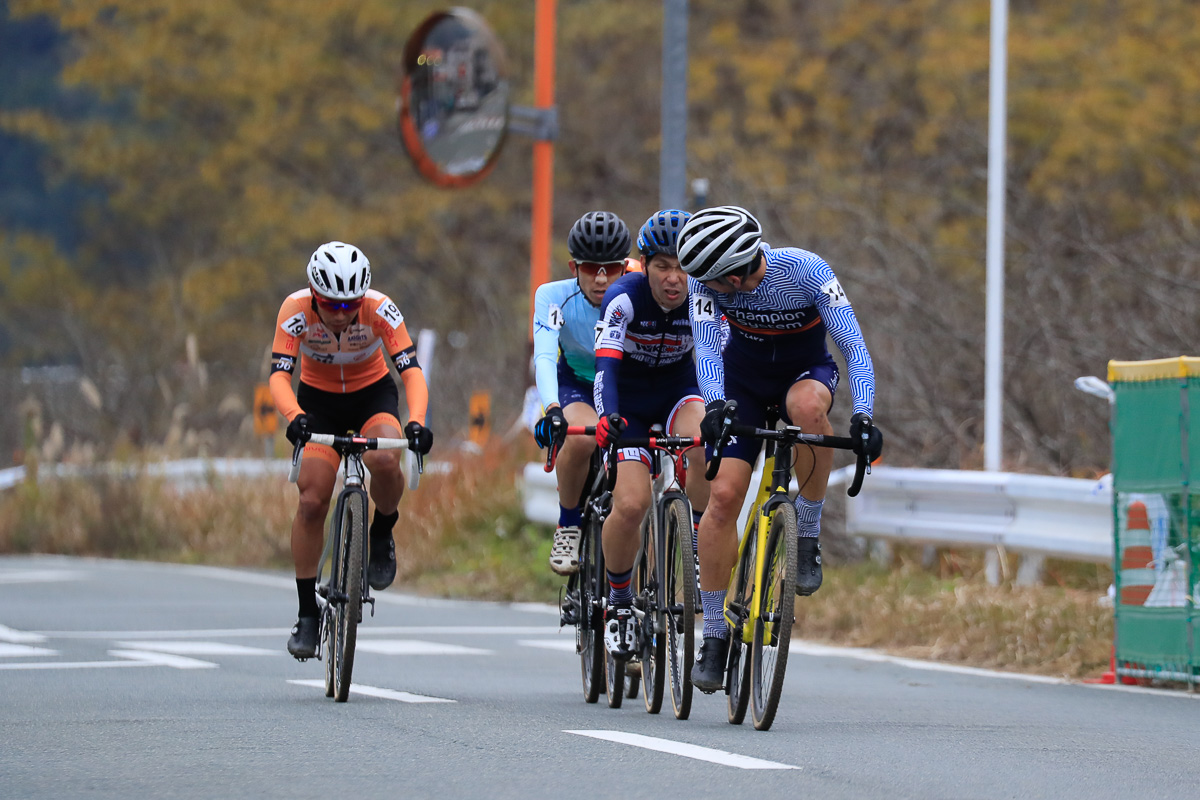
[679, 206, 883, 692]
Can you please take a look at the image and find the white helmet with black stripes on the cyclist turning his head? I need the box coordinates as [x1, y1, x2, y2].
[678, 205, 762, 281]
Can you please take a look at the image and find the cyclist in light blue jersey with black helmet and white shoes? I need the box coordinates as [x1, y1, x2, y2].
[533, 211, 632, 575]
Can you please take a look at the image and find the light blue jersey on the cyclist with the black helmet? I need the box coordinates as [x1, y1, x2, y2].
[533, 278, 600, 408]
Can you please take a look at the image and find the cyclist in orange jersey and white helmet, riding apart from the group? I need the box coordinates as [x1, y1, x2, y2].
[270, 241, 433, 660]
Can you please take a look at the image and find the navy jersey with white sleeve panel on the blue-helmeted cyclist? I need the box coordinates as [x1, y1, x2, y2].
[593, 272, 696, 416]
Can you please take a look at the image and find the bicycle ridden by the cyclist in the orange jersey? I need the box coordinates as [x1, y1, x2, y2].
[288, 433, 425, 703]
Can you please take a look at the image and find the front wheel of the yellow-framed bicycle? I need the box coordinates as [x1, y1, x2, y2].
[750, 503, 798, 730]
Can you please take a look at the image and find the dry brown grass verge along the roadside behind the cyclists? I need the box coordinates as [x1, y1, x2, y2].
[0, 445, 1112, 678]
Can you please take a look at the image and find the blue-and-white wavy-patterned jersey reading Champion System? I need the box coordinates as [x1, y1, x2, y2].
[688, 245, 875, 414]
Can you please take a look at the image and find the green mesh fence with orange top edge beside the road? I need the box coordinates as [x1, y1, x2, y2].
[1109, 357, 1200, 684]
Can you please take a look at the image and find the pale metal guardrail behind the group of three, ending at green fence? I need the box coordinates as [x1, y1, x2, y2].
[522, 463, 1112, 564]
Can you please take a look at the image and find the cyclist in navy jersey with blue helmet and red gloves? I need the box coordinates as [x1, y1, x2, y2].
[594, 209, 708, 660]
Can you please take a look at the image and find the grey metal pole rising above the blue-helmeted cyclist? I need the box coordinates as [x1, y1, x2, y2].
[659, 0, 688, 209]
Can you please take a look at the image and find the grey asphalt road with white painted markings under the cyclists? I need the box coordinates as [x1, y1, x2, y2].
[0, 557, 1200, 800]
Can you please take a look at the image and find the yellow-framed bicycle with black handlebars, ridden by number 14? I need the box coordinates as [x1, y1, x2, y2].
[707, 402, 870, 730]
